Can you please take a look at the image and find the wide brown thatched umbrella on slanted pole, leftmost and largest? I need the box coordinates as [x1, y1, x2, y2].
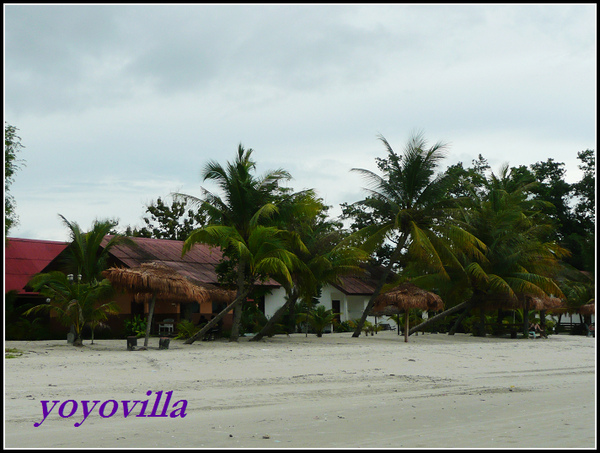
[102, 262, 209, 347]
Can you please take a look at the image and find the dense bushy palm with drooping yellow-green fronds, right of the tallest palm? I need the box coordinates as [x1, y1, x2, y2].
[411, 166, 568, 335]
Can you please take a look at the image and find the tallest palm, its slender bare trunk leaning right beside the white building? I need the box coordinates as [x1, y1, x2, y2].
[353, 134, 483, 337]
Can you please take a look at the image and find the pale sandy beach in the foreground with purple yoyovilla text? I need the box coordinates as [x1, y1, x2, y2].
[4, 331, 597, 449]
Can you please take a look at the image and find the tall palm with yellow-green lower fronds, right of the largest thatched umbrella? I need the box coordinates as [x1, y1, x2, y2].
[176, 144, 299, 341]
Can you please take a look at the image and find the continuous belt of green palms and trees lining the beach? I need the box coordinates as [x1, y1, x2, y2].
[5, 120, 595, 342]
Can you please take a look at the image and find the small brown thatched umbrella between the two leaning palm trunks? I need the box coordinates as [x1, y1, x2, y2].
[371, 282, 444, 342]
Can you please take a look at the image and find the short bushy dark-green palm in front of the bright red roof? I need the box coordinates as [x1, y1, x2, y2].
[25, 271, 118, 346]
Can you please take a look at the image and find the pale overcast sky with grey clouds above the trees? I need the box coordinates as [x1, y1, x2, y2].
[4, 3, 597, 241]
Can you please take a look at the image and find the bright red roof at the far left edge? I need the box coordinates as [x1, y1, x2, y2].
[4, 238, 68, 294]
